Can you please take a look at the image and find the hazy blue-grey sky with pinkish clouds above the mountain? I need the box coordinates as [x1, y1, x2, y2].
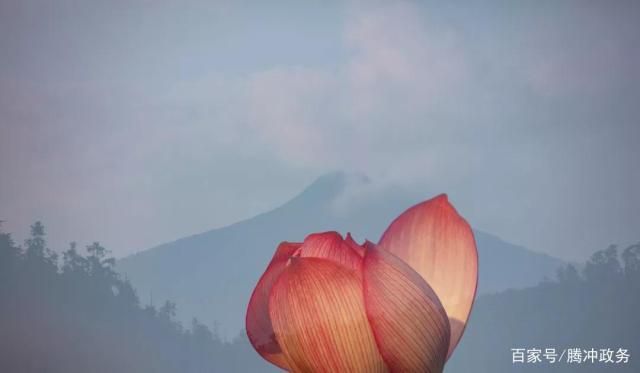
[0, 0, 640, 260]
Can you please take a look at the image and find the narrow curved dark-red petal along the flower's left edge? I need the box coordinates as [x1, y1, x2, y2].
[245, 242, 301, 369]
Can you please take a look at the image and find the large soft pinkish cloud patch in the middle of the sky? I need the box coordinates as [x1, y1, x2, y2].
[210, 3, 467, 181]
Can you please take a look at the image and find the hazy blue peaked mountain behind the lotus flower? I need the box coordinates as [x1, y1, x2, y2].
[118, 173, 562, 337]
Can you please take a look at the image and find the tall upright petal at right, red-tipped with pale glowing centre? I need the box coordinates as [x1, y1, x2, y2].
[378, 194, 478, 356]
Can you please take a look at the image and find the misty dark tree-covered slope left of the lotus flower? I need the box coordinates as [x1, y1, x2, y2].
[0, 222, 276, 373]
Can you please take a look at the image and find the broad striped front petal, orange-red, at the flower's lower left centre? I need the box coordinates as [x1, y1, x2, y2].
[269, 258, 386, 373]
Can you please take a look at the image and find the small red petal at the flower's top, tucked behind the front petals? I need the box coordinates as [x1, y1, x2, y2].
[298, 232, 362, 272]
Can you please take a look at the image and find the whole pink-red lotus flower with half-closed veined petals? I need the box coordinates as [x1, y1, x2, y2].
[246, 195, 478, 372]
